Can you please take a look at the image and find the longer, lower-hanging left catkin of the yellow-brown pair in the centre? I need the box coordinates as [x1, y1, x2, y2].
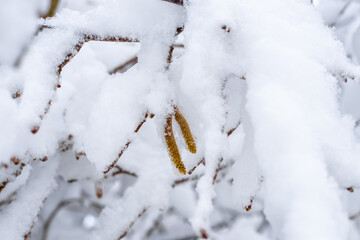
[164, 115, 186, 175]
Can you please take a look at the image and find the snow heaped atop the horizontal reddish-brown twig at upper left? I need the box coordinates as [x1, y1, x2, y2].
[45, 0, 183, 38]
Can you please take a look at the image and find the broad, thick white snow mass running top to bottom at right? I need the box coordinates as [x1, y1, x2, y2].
[236, 1, 359, 239]
